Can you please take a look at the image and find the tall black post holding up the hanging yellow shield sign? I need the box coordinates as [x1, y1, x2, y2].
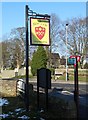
[25, 5, 29, 112]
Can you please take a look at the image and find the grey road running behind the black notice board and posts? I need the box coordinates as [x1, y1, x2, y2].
[30, 79, 88, 96]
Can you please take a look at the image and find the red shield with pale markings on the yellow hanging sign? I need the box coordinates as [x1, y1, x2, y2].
[35, 26, 45, 40]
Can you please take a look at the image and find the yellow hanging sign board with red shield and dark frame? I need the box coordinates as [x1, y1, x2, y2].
[30, 18, 50, 45]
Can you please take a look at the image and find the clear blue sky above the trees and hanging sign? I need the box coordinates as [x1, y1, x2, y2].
[0, 0, 86, 41]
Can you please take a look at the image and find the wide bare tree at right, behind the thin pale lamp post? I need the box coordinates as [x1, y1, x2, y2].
[59, 18, 87, 64]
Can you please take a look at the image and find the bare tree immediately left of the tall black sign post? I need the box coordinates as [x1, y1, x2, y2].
[10, 27, 25, 68]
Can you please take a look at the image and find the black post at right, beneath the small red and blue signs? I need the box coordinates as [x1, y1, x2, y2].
[74, 56, 79, 120]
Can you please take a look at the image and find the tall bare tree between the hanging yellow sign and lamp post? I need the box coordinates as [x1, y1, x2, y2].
[46, 13, 60, 67]
